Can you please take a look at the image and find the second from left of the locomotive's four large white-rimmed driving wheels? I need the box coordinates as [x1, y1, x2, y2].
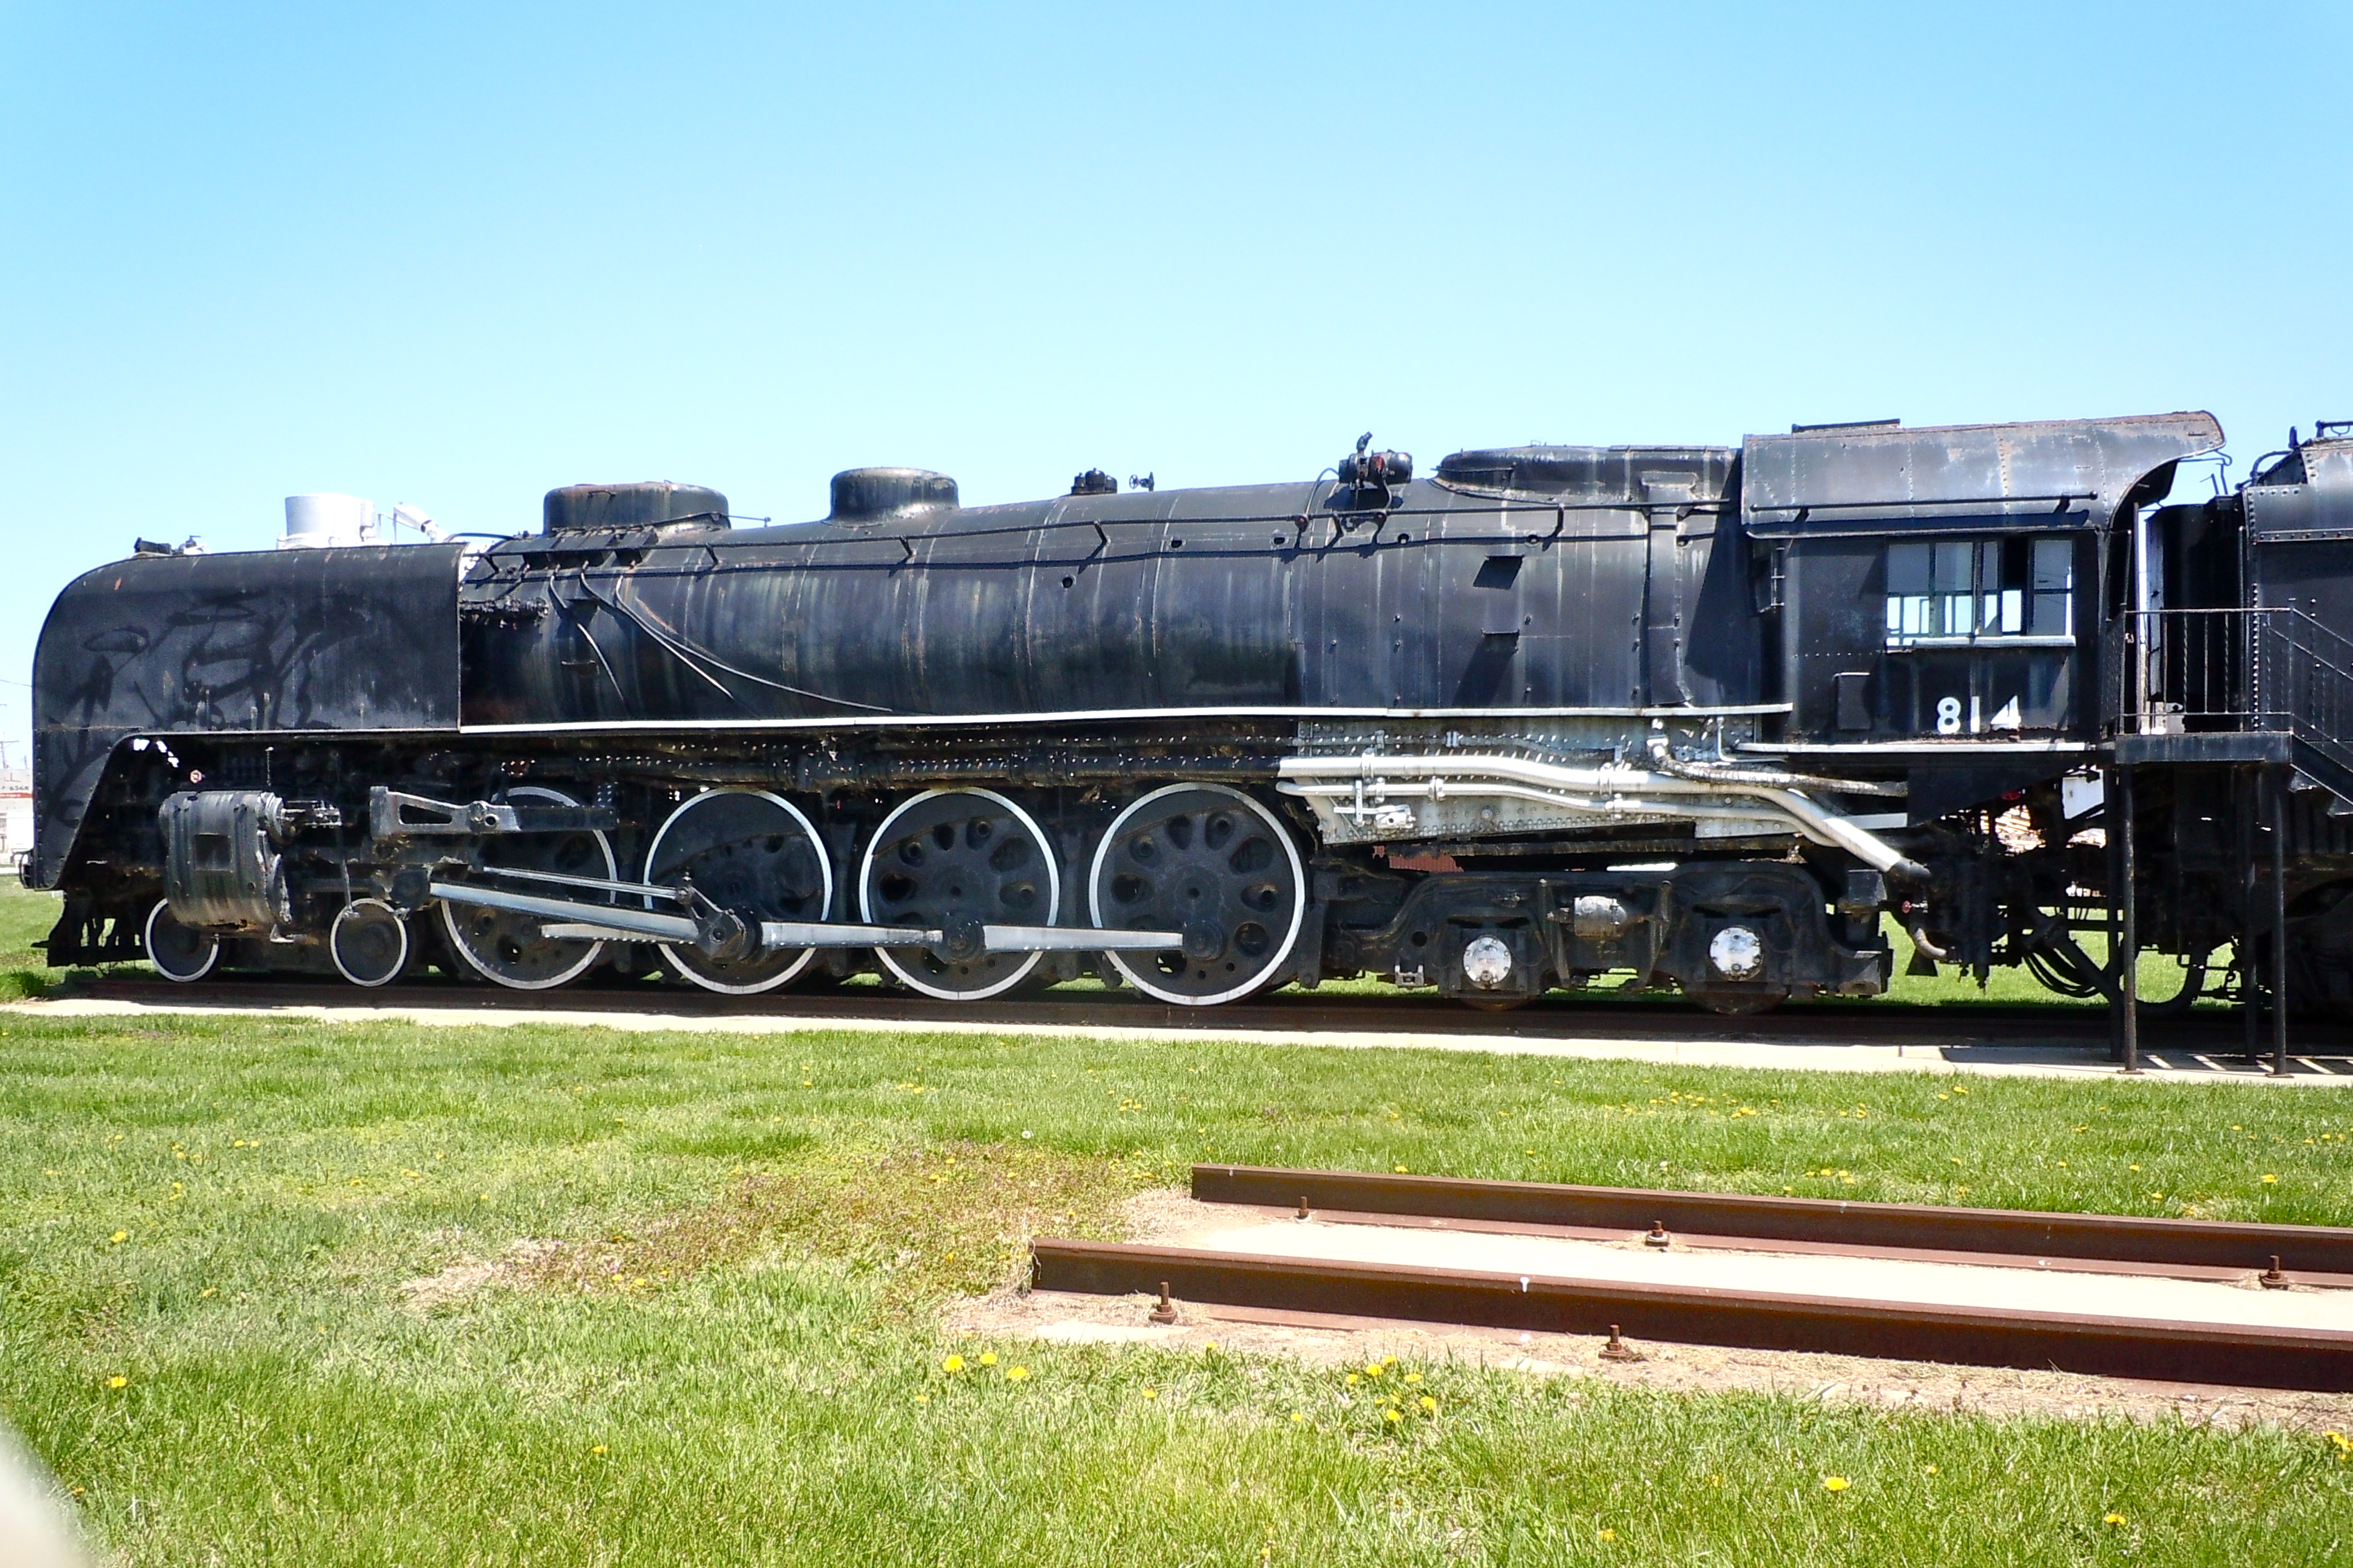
[644, 790, 833, 997]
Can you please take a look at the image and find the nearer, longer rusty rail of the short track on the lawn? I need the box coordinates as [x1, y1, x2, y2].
[1031, 1241, 2353, 1394]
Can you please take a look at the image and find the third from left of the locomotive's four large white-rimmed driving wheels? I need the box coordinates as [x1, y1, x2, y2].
[859, 790, 1061, 1002]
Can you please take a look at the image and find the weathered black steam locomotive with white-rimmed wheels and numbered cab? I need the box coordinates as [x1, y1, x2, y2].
[26, 414, 2353, 1013]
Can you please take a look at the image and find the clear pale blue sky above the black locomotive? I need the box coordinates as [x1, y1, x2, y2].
[0, 0, 2353, 762]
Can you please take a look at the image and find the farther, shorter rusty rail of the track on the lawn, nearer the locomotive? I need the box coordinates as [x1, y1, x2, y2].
[1193, 1166, 2353, 1274]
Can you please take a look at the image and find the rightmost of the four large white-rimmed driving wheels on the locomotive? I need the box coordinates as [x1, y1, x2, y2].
[1087, 785, 1308, 1006]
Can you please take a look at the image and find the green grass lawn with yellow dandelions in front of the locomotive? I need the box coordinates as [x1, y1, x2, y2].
[0, 1013, 2353, 1563]
